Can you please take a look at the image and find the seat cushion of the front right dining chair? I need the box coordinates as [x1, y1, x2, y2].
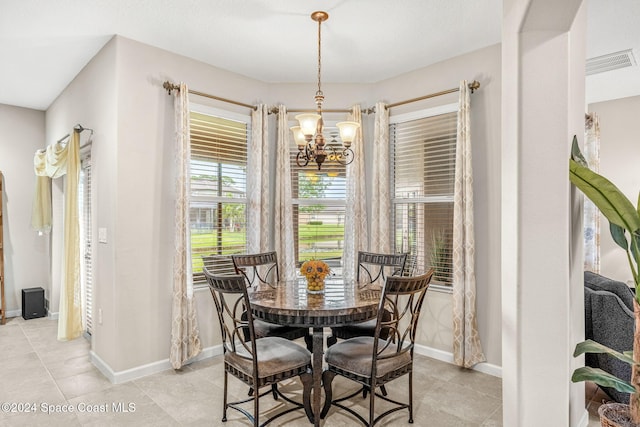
[325, 337, 411, 377]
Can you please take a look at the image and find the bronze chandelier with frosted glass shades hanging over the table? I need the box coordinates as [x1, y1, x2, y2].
[291, 11, 360, 170]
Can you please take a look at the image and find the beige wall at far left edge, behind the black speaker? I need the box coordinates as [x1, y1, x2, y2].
[0, 104, 50, 316]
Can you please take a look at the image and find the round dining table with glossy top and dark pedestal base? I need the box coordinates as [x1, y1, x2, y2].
[249, 277, 381, 426]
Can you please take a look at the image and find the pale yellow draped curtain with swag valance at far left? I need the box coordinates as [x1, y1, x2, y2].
[31, 129, 82, 341]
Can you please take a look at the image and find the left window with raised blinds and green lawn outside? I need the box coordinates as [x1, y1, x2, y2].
[189, 110, 250, 284]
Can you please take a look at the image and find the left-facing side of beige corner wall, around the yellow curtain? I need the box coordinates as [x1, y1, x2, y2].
[46, 36, 123, 361]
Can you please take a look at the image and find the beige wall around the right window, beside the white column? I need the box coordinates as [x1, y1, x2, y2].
[373, 45, 502, 366]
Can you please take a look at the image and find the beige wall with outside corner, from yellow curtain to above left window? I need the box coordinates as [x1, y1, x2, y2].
[47, 37, 265, 373]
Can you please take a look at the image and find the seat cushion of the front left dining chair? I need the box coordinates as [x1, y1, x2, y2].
[224, 337, 311, 378]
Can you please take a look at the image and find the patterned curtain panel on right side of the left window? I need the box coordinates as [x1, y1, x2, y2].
[247, 104, 270, 253]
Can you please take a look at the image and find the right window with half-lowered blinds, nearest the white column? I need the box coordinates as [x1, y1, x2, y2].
[389, 104, 457, 286]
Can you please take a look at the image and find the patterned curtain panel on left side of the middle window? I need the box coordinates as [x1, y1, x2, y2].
[274, 105, 296, 280]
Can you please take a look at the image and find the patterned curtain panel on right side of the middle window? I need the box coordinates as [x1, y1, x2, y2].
[342, 105, 368, 280]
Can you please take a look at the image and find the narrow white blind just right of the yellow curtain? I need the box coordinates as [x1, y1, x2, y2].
[78, 154, 93, 334]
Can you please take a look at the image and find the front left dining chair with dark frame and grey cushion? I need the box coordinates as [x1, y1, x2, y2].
[205, 270, 312, 427]
